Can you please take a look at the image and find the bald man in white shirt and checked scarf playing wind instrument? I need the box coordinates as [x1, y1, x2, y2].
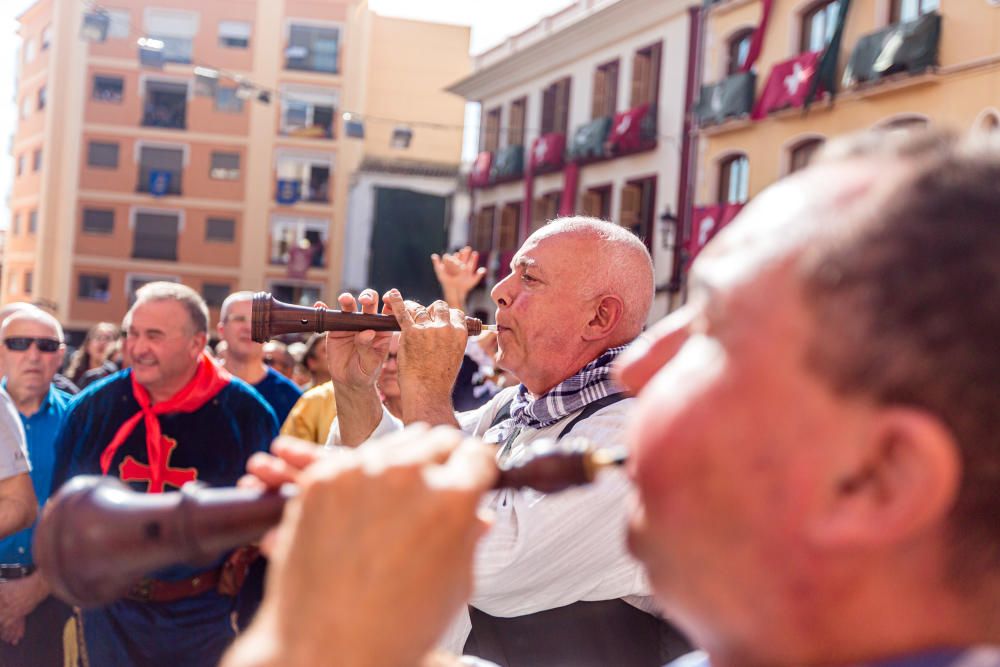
[328, 218, 685, 667]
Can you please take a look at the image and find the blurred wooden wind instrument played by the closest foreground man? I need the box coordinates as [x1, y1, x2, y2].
[34, 446, 625, 607]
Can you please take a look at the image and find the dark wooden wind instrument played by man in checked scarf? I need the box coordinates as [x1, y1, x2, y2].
[250, 292, 492, 343]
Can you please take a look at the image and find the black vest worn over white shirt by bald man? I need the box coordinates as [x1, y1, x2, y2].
[464, 394, 691, 667]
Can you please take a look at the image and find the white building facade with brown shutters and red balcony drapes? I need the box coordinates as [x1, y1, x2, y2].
[449, 0, 697, 320]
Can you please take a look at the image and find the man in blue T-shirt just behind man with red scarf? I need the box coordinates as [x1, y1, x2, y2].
[218, 291, 302, 424]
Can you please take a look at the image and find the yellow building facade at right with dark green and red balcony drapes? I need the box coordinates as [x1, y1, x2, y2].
[691, 0, 1000, 254]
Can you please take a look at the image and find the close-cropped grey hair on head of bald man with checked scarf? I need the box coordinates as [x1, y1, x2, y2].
[532, 216, 654, 339]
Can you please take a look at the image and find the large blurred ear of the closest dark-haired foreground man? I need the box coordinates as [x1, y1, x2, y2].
[811, 407, 962, 548]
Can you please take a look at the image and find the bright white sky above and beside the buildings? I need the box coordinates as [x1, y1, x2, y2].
[0, 0, 572, 229]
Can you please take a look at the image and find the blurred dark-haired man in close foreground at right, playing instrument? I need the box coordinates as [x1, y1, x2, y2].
[225, 126, 1000, 667]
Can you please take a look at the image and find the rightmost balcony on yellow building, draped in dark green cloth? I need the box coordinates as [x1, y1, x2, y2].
[843, 12, 941, 88]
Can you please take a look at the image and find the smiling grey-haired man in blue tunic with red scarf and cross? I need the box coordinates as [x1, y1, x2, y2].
[54, 282, 278, 667]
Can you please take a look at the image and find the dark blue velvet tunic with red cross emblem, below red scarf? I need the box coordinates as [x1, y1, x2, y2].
[53, 370, 278, 667]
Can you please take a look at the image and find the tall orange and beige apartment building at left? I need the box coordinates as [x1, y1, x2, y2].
[2, 0, 469, 331]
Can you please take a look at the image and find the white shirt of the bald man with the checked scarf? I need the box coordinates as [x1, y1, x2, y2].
[327, 387, 649, 653]
